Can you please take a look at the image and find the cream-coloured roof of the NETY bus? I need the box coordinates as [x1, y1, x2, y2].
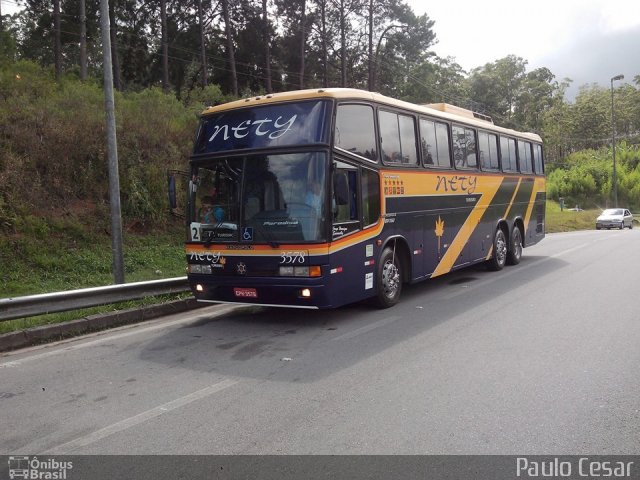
[202, 88, 542, 142]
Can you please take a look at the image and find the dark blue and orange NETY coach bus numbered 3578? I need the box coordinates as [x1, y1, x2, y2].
[169, 89, 545, 309]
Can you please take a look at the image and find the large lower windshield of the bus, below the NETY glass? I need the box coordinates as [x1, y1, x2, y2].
[189, 152, 327, 245]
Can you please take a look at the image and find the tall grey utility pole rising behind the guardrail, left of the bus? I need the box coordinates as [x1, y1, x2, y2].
[100, 0, 124, 283]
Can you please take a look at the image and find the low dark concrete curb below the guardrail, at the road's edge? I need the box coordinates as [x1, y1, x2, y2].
[0, 298, 207, 352]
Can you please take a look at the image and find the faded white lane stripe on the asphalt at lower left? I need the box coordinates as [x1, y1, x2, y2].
[43, 379, 238, 455]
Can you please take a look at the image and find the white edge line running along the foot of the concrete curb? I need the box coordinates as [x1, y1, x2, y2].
[0, 305, 238, 369]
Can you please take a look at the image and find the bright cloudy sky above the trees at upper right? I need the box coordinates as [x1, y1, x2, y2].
[408, 0, 640, 97]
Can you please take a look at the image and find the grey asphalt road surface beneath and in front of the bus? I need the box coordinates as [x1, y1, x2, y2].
[0, 230, 640, 455]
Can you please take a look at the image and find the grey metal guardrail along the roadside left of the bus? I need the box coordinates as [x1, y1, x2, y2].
[0, 277, 189, 322]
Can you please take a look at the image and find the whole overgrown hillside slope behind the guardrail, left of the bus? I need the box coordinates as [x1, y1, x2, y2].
[0, 61, 232, 297]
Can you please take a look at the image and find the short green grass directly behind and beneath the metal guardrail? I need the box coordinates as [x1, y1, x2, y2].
[0, 218, 188, 333]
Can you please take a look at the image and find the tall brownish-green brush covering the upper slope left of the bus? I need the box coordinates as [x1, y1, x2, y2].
[0, 61, 201, 231]
